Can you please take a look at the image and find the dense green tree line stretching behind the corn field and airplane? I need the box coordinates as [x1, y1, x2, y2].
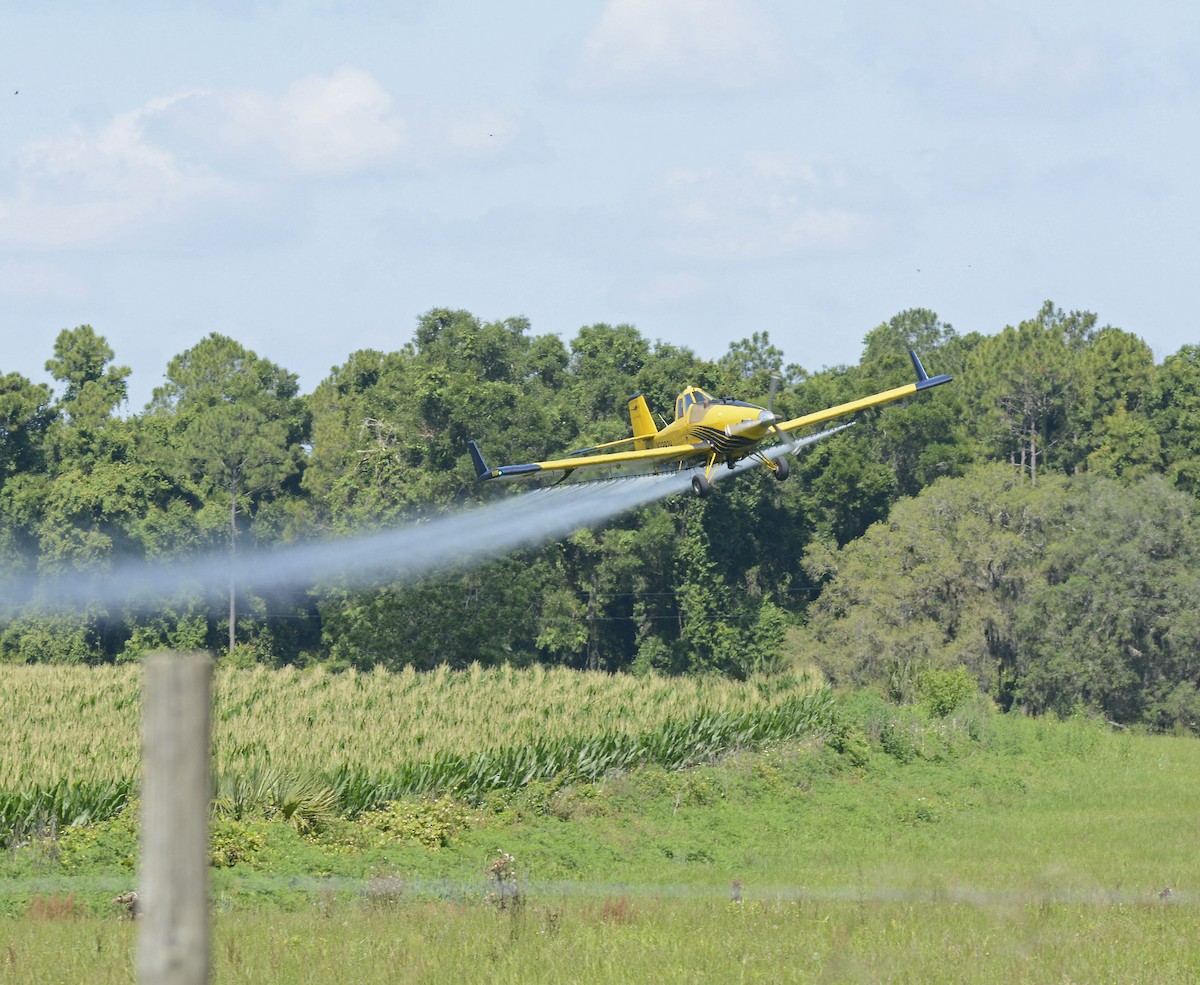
[0, 302, 1200, 720]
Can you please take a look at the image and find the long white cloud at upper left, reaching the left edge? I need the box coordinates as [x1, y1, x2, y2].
[0, 68, 517, 250]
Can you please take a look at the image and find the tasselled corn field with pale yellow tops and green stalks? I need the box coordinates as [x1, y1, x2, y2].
[0, 666, 833, 841]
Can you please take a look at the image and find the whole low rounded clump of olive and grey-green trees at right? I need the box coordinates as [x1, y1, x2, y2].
[802, 468, 1200, 727]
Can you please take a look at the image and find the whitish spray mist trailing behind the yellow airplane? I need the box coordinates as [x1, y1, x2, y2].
[7, 425, 850, 609]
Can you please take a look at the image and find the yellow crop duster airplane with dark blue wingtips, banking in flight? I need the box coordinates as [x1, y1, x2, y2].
[468, 349, 950, 495]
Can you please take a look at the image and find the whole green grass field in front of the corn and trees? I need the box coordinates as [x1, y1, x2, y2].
[0, 667, 1200, 985]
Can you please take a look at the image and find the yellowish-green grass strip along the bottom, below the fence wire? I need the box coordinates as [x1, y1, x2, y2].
[9, 896, 1200, 985]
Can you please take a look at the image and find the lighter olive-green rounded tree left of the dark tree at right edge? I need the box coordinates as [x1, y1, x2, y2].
[803, 466, 1063, 704]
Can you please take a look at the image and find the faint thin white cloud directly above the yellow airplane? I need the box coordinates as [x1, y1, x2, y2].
[659, 157, 872, 260]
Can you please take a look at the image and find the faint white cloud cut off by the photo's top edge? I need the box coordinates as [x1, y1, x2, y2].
[577, 0, 788, 89]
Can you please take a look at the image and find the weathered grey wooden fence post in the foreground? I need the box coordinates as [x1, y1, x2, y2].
[137, 653, 212, 985]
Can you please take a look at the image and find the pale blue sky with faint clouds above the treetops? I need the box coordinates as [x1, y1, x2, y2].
[0, 0, 1200, 412]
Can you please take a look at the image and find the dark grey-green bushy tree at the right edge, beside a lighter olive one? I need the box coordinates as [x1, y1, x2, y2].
[1015, 478, 1200, 726]
